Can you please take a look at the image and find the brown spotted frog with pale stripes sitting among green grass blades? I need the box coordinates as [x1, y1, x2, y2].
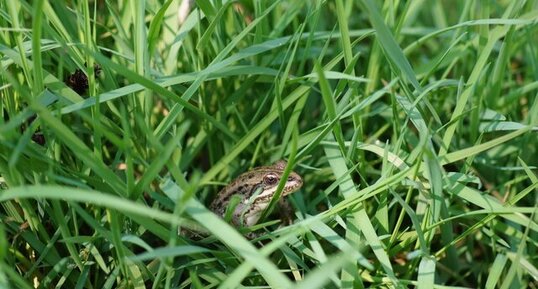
[209, 160, 303, 231]
